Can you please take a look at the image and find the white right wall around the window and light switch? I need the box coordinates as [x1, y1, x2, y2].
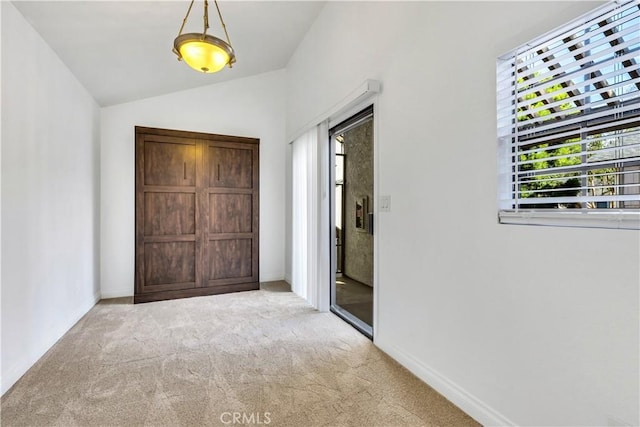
[287, 2, 640, 425]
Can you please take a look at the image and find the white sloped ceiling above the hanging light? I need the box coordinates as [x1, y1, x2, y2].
[13, 0, 325, 106]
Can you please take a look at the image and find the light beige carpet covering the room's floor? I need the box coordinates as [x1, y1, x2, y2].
[1, 282, 477, 427]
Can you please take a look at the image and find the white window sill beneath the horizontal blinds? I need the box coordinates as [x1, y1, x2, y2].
[498, 210, 640, 230]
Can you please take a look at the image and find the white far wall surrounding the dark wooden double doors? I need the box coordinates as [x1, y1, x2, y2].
[101, 71, 286, 298]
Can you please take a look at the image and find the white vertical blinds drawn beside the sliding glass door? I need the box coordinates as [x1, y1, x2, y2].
[291, 124, 330, 311]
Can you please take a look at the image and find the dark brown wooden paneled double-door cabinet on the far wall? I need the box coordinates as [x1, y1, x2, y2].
[134, 127, 259, 302]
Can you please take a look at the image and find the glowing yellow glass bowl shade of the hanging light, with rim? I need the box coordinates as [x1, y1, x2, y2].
[173, 33, 236, 73]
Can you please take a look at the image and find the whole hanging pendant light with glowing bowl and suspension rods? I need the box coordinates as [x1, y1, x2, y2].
[173, 0, 236, 73]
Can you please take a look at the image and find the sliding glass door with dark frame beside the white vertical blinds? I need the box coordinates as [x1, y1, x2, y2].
[329, 106, 374, 338]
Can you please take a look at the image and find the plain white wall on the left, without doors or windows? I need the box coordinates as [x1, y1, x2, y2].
[1, 1, 100, 393]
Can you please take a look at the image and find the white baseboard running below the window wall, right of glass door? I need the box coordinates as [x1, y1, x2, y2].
[375, 337, 516, 426]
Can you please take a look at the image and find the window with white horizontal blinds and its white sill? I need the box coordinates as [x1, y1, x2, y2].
[497, 0, 640, 229]
